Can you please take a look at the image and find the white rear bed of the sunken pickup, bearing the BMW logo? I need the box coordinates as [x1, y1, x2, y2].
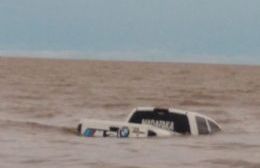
[78, 119, 174, 138]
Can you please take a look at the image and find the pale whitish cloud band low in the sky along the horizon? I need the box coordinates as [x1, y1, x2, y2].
[0, 50, 260, 66]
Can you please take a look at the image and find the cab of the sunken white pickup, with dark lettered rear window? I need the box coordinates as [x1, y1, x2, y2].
[126, 107, 221, 135]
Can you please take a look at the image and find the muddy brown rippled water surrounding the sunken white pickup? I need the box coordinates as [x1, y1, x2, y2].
[0, 58, 260, 167]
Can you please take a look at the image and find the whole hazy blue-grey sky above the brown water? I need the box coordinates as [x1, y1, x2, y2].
[0, 0, 260, 64]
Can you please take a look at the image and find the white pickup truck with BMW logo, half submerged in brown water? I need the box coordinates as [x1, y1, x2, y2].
[78, 107, 221, 138]
